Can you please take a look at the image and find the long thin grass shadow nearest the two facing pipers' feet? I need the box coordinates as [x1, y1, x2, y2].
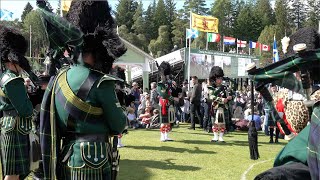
[126, 146, 216, 154]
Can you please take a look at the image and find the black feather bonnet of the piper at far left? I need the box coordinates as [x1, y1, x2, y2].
[0, 25, 31, 72]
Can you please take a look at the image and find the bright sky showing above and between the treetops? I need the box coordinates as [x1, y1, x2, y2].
[0, 0, 196, 19]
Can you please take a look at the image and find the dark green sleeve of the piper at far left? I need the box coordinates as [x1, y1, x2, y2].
[4, 78, 33, 117]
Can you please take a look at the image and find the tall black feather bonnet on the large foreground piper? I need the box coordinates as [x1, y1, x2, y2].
[66, 1, 127, 73]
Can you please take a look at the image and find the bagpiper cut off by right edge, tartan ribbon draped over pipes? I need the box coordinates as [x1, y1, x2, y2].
[248, 28, 320, 180]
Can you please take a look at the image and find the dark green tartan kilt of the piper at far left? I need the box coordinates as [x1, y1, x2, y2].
[0, 117, 30, 176]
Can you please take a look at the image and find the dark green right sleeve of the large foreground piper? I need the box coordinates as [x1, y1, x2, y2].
[96, 81, 126, 135]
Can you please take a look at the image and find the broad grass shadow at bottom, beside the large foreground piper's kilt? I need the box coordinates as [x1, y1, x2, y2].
[119, 159, 201, 179]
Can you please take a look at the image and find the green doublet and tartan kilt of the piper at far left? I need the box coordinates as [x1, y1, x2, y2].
[0, 70, 33, 175]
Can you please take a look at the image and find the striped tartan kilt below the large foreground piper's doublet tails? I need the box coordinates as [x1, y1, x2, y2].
[58, 163, 111, 180]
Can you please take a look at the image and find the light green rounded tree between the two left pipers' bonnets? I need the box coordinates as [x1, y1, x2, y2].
[23, 11, 48, 56]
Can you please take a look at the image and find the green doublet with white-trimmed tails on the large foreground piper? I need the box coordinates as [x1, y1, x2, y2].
[55, 65, 126, 179]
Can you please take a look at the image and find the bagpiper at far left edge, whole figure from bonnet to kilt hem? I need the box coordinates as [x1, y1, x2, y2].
[0, 25, 33, 179]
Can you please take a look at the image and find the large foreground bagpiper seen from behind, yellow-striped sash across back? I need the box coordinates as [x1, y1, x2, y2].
[40, 1, 126, 180]
